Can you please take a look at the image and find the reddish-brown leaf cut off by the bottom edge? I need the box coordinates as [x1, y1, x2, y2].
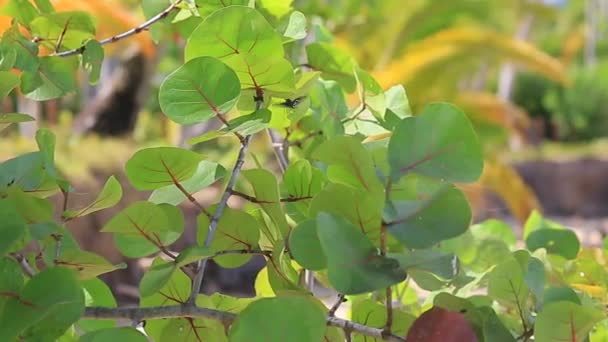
[406, 307, 478, 342]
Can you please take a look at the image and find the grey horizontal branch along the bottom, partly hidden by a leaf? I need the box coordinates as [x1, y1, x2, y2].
[82, 305, 405, 342]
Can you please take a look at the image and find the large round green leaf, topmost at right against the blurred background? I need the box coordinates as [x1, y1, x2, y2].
[388, 103, 483, 182]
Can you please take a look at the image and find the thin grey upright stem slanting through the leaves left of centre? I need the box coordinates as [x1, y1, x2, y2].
[188, 90, 264, 305]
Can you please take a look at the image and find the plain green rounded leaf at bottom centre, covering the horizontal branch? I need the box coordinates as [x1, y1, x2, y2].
[230, 295, 325, 342]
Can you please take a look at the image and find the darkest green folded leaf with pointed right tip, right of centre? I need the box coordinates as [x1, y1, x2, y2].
[317, 213, 406, 294]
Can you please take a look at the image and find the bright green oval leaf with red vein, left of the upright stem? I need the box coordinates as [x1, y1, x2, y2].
[125, 147, 203, 190]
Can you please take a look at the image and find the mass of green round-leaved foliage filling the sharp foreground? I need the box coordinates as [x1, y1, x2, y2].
[0, 0, 608, 341]
